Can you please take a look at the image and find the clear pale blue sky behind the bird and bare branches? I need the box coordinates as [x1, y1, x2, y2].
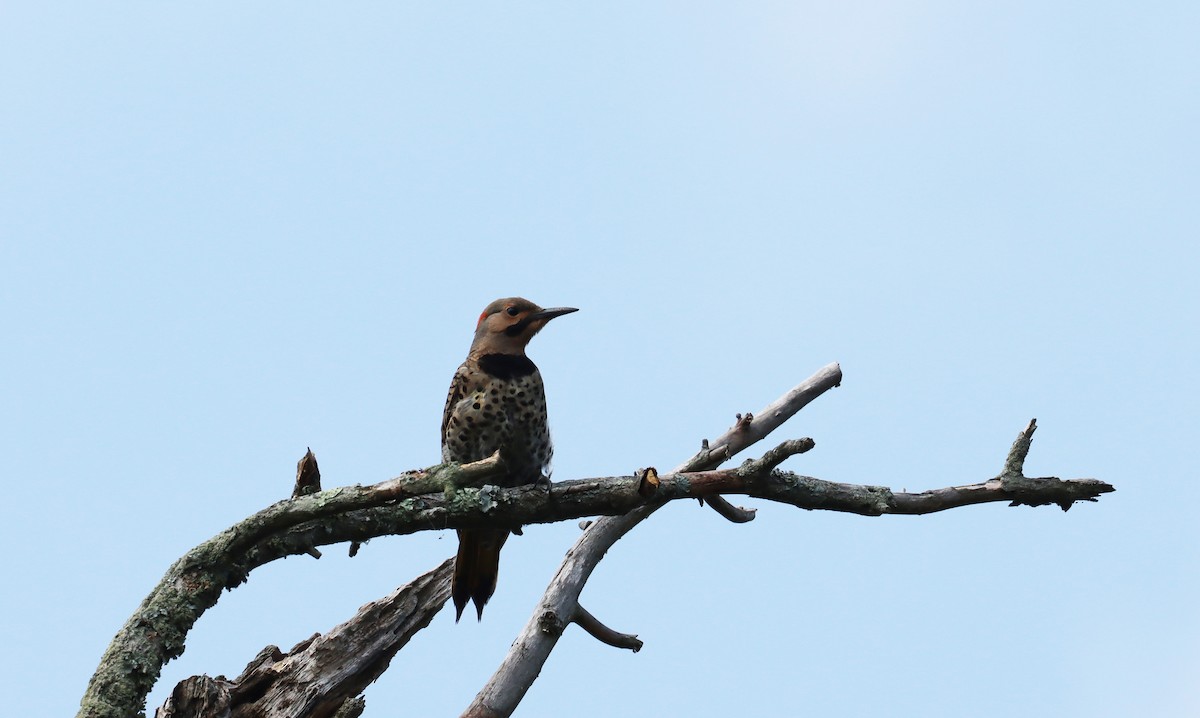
[0, 1, 1200, 718]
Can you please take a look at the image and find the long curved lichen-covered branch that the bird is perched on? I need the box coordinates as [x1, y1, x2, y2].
[79, 451, 1112, 717]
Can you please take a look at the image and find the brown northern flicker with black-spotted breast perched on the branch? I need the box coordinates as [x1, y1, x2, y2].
[442, 297, 577, 621]
